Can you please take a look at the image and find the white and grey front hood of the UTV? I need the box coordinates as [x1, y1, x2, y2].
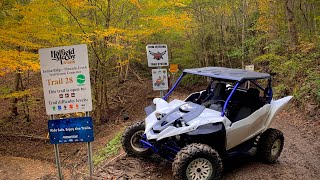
[145, 98, 223, 140]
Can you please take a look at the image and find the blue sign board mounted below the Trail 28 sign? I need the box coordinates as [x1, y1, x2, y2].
[48, 117, 94, 144]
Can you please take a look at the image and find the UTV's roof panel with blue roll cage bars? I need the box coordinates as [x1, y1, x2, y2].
[163, 67, 273, 117]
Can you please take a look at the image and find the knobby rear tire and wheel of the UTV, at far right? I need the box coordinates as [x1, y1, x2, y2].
[257, 128, 284, 164]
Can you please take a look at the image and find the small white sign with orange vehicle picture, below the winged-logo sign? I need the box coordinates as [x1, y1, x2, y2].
[152, 69, 168, 90]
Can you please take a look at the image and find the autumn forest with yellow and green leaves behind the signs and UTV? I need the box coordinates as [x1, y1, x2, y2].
[0, 0, 320, 129]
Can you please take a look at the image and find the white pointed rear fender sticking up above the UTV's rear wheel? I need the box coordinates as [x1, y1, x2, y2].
[264, 96, 292, 129]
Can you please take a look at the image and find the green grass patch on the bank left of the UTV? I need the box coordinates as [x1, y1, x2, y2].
[93, 131, 123, 165]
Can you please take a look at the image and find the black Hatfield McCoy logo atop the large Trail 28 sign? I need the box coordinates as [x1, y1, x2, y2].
[51, 48, 76, 64]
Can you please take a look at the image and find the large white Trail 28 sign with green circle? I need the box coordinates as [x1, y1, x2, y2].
[39, 44, 92, 115]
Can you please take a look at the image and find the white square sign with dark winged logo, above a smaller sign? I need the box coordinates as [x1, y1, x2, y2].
[146, 44, 169, 67]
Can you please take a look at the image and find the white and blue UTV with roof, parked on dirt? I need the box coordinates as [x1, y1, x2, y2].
[122, 67, 292, 180]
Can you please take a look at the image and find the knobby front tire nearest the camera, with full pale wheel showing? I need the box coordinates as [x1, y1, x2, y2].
[172, 143, 222, 180]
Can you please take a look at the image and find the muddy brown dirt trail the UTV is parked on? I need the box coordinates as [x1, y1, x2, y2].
[96, 112, 320, 180]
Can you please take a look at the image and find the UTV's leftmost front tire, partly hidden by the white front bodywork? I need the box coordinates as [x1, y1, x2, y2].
[121, 121, 152, 157]
